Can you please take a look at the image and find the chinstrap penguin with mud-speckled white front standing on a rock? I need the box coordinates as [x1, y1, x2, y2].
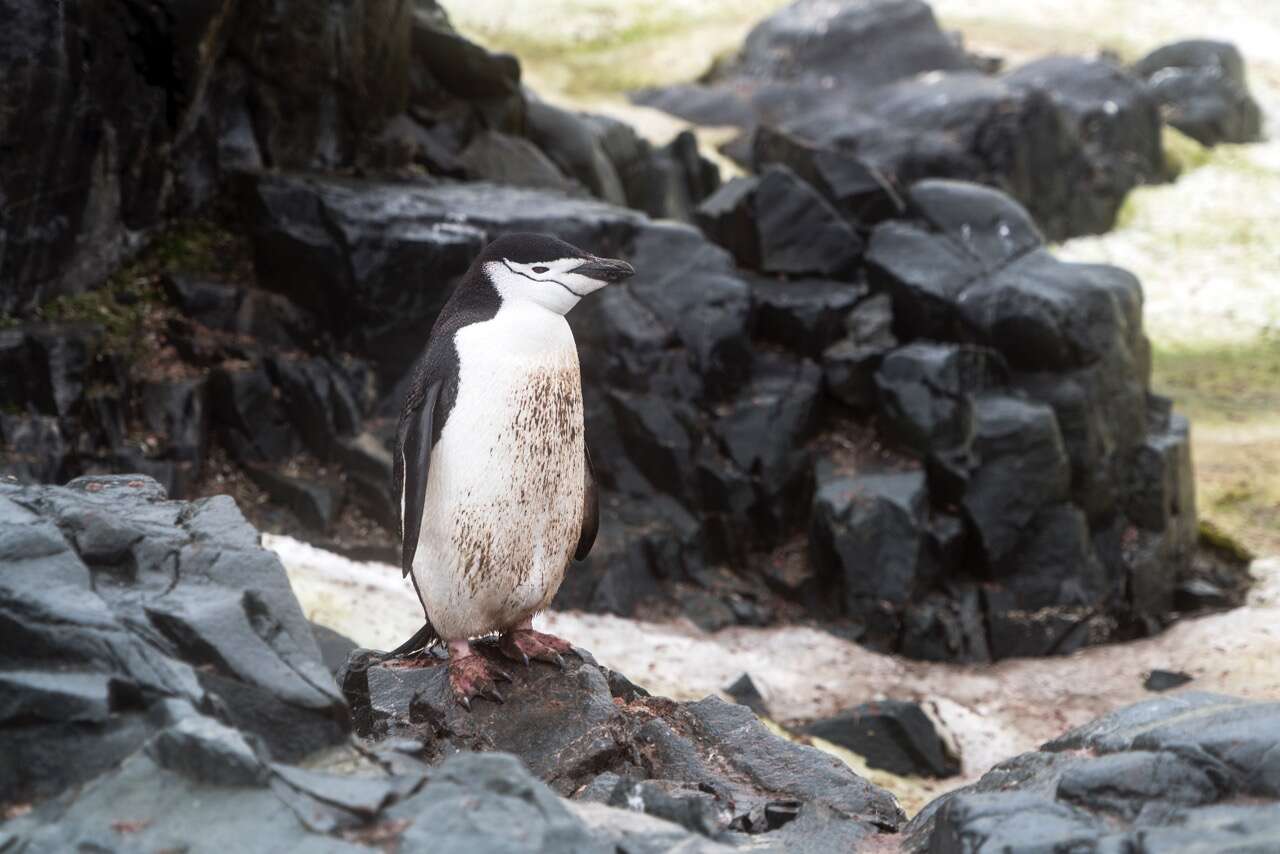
[388, 233, 635, 709]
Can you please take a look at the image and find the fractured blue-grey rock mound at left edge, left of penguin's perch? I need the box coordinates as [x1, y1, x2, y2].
[0, 475, 347, 798]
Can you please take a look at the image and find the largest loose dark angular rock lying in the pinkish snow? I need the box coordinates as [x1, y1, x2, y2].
[804, 700, 960, 777]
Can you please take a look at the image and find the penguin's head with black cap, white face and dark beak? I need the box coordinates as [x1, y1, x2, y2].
[477, 233, 635, 314]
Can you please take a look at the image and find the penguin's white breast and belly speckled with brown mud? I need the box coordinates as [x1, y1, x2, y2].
[413, 302, 585, 640]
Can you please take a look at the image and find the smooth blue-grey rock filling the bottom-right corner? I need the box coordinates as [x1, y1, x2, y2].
[905, 694, 1280, 854]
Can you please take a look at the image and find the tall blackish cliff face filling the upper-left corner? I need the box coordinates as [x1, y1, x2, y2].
[0, 0, 412, 312]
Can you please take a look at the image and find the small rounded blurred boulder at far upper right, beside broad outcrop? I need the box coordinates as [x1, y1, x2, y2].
[1133, 40, 1262, 146]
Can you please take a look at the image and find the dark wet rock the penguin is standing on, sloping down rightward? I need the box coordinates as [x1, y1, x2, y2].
[339, 644, 901, 841]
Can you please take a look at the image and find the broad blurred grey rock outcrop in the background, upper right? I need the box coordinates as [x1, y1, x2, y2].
[636, 0, 1164, 239]
